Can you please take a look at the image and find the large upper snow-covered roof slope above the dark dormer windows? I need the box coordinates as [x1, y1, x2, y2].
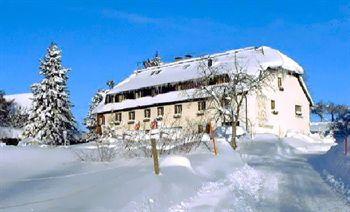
[109, 46, 304, 93]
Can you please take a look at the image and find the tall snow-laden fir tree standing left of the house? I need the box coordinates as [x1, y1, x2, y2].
[24, 43, 77, 145]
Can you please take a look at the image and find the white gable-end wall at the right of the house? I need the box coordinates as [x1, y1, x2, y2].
[248, 71, 310, 136]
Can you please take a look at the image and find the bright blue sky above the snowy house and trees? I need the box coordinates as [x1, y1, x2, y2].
[0, 0, 350, 127]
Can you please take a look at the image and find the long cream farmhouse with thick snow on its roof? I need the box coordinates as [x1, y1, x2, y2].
[94, 46, 313, 135]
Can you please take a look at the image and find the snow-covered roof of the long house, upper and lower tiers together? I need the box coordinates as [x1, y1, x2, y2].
[93, 46, 304, 113]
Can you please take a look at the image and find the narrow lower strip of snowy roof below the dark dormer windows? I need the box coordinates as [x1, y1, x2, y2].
[93, 89, 200, 113]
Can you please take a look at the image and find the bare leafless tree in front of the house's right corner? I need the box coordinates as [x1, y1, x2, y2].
[194, 54, 272, 149]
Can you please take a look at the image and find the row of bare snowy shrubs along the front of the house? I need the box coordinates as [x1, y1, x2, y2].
[77, 119, 212, 161]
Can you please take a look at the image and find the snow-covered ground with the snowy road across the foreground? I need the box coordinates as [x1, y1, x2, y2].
[0, 134, 350, 211]
